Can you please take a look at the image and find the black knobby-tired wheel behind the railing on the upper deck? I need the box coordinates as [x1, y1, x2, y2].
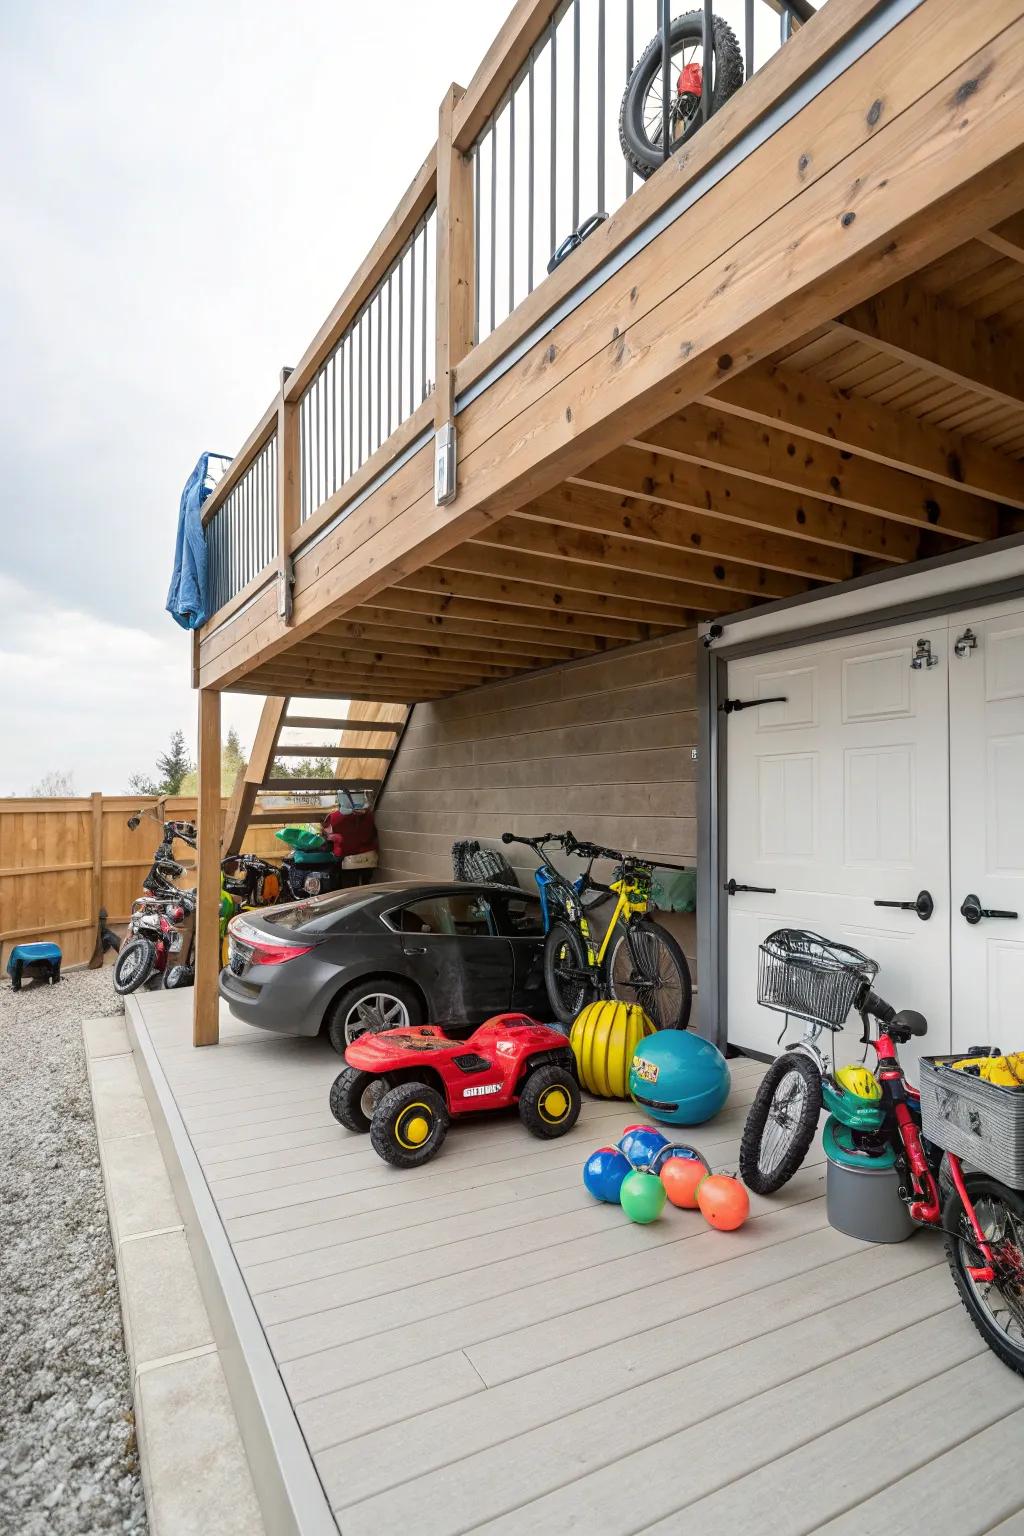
[619, 11, 743, 181]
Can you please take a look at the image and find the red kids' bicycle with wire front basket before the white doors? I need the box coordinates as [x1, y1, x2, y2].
[740, 928, 1024, 1375]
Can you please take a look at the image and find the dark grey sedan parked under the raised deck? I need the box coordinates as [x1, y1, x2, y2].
[221, 880, 550, 1052]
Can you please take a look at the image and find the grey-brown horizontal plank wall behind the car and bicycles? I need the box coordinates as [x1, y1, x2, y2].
[376, 631, 697, 966]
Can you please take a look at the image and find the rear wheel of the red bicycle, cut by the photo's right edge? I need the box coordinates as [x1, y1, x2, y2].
[943, 1174, 1024, 1376]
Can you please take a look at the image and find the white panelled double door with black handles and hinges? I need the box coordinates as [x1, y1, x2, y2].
[726, 601, 1024, 1061]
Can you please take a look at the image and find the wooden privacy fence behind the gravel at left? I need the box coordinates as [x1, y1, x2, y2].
[0, 794, 284, 968]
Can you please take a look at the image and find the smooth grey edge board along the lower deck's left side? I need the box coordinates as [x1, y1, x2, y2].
[124, 994, 338, 1536]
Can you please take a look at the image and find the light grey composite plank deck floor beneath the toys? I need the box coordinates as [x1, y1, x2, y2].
[132, 992, 1024, 1536]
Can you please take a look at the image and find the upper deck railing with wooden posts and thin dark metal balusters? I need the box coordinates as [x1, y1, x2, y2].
[203, 0, 815, 622]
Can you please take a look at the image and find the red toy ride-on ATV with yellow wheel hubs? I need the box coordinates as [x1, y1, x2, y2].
[330, 1014, 580, 1167]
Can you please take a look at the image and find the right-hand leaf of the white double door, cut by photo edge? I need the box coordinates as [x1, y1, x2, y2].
[949, 608, 1024, 1051]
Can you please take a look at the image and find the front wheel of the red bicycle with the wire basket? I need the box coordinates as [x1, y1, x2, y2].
[740, 1051, 821, 1195]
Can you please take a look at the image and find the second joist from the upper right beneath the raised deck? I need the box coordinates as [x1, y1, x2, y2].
[832, 280, 1024, 410]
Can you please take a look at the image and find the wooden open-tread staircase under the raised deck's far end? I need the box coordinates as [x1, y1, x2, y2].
[221, 697, 410, 856]
